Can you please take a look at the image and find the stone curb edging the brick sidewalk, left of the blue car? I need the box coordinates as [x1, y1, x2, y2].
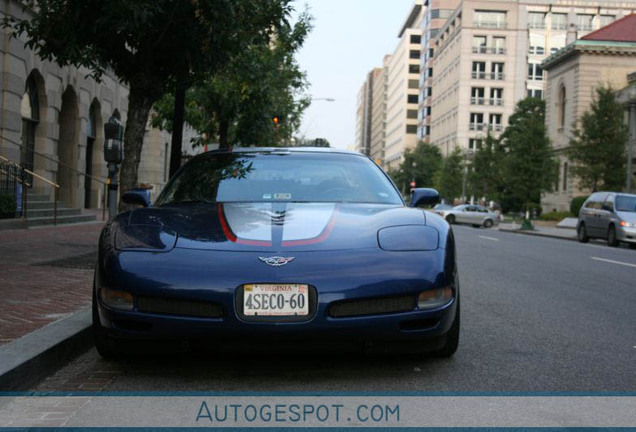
[0, 307, 93, 391]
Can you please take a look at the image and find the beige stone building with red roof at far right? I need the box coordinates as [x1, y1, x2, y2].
[542, 15, 636, 211]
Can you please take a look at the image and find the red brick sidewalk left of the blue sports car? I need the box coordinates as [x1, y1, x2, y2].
[0, 223, 103, 345]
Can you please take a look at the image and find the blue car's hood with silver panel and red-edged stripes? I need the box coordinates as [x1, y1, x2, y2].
[118, 203, 426, 252]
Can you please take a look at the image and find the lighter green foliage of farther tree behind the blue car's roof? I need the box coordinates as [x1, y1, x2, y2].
[152, 12, 311, 148]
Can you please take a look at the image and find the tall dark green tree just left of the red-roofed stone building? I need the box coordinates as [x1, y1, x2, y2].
[501, 98, 556, 210]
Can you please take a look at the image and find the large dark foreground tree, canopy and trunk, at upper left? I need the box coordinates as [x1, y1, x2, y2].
[3, 0, 291, 190]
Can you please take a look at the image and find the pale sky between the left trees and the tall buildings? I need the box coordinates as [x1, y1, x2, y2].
[296, 0, 413, 149]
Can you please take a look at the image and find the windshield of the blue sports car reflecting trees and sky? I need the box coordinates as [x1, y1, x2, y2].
[156, 152, 403, 206]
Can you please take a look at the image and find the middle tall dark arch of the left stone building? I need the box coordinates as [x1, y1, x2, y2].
[57, 85, 80, 207]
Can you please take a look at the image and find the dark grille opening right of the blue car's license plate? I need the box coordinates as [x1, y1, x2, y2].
[329, 295, 416, 318]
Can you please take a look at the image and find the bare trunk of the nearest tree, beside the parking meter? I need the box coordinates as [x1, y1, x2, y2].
[119, 84, 156, 206]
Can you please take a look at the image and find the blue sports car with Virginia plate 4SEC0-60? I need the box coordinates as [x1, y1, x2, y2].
[93, 148, 460, 357]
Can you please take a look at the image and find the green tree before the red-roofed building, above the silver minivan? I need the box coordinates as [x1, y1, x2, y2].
[568, 86, 628, 192]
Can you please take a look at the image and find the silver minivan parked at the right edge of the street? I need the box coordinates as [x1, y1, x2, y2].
[577, 192, 636, 249]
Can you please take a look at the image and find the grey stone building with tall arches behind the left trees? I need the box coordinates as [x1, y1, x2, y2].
[0, 0, 199, 219]
